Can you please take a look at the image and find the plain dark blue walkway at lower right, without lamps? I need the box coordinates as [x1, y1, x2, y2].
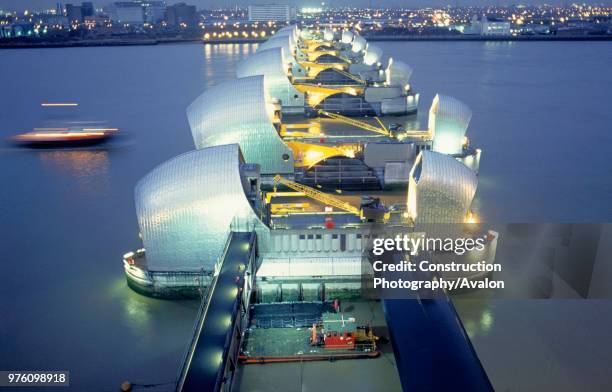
[383, 252, 493, 392]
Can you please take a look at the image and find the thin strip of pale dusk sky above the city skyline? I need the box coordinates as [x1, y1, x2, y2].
[0, 0, 612, 10]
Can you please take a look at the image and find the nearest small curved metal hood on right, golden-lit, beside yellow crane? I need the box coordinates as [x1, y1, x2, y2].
[408, 150, 478, 223]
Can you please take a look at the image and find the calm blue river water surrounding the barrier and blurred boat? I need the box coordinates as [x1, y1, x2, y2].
[0, 42, 612, 391]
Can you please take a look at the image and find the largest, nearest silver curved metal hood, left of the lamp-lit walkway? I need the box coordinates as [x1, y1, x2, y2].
[134, 144, 268, 272]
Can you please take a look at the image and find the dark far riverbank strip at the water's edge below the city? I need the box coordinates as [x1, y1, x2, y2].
[0, 34, 612, 49]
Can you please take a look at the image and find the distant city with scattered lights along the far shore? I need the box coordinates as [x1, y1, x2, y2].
[0, 2, 612, 46]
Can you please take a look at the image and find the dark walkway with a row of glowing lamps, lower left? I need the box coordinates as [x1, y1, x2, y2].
[177, 232, 257, 391]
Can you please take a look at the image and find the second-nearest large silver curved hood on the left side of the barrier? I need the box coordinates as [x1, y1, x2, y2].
[187, 75, 294, 174]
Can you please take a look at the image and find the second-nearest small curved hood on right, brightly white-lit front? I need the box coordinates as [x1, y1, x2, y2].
[429, 94, 472, 154]
